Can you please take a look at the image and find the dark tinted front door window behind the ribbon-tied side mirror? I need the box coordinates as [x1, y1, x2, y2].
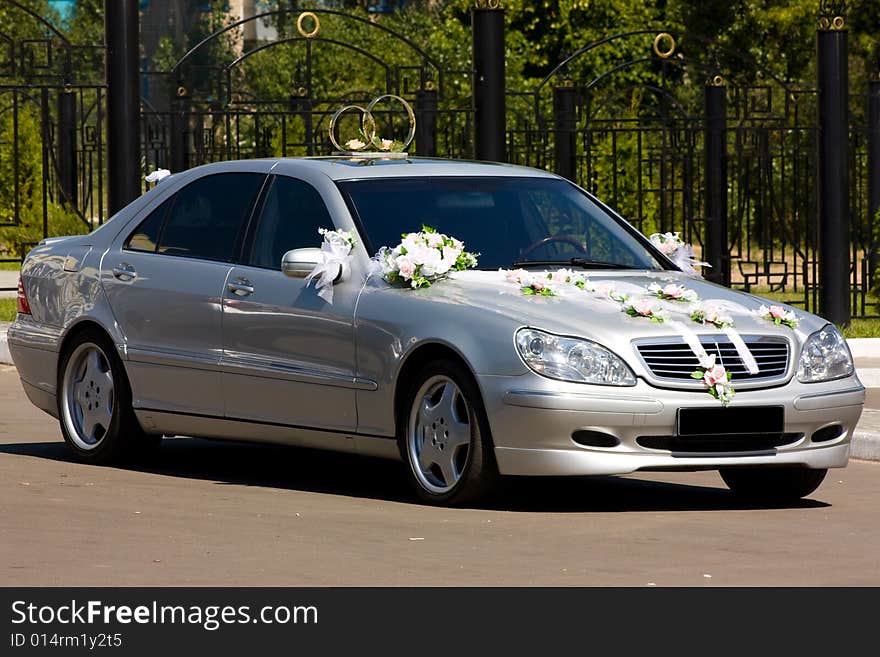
[250, 176, 333, 269]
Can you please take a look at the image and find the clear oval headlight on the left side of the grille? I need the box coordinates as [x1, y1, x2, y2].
[516, 328, 636, 386]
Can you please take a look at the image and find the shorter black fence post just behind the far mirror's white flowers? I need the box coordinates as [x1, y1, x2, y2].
[703, 75, 730, 286]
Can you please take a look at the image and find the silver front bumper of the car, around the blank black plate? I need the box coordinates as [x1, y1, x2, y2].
[479, 373, 865, 475]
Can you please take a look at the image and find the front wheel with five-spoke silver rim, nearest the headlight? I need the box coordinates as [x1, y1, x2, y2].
[397, 361, 499, 506]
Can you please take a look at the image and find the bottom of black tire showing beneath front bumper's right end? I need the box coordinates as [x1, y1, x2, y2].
[720, 467, 828, 503]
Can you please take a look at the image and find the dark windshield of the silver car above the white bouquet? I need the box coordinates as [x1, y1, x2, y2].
[339, 177, 663, 269]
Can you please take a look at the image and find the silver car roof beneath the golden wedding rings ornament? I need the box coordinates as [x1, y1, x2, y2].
[185, 156, 558, 180]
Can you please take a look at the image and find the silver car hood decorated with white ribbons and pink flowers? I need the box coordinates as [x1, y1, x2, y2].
[402, 270, 827, 353]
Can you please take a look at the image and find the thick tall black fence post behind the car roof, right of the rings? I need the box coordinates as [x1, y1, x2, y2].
[471, 9, 507, 162]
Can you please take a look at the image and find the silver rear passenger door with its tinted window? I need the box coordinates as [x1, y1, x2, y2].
[102, 172, 266, 417]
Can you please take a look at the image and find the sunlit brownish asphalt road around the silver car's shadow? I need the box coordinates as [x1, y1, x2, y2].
[0, 367, 880, 586]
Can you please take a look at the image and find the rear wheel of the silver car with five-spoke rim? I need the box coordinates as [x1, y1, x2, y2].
[57, 328, 162, 464]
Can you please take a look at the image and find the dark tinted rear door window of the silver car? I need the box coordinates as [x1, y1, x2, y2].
[159, 173, 266, 261]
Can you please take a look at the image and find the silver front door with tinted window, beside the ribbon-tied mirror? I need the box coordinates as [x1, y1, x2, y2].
[223, 175, 362, 432]
